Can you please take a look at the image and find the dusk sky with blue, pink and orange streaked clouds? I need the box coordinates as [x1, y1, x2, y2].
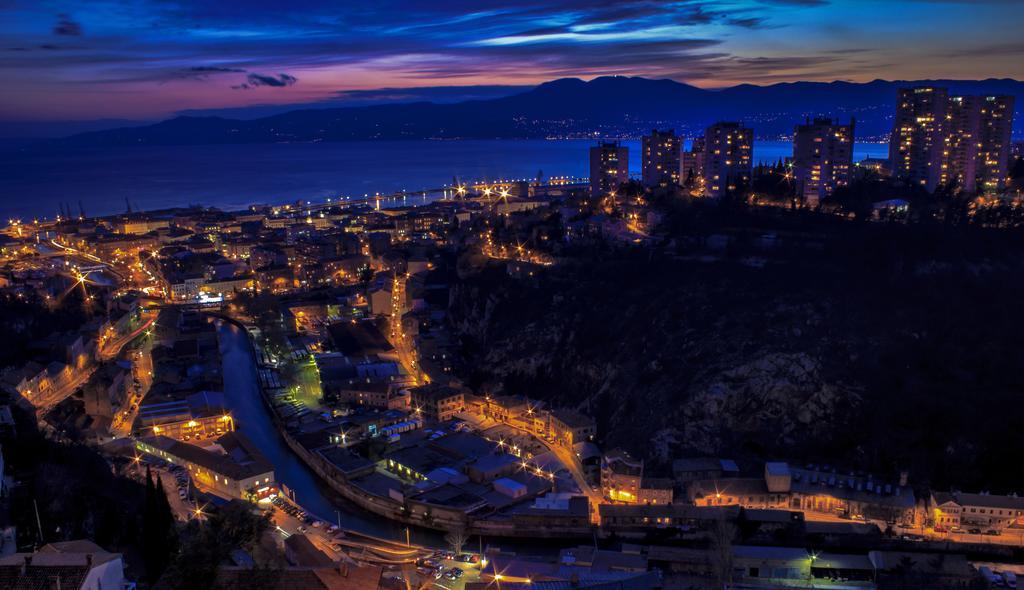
[0, 0, 1024, 121]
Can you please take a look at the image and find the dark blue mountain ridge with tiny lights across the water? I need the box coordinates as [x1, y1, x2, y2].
[55, 77, 1024, 146]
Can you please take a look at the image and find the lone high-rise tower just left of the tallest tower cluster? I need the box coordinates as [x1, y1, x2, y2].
[793, 119, 854, 207]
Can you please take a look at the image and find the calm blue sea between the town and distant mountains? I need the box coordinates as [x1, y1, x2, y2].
[0, 139, 887, 221]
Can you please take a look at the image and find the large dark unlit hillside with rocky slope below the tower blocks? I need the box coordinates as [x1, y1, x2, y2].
[452, 209, 1024, 492]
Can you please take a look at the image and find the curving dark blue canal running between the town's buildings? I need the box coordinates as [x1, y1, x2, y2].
[218, 321, 443, 547]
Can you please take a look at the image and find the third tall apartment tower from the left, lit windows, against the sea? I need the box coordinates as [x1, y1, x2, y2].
[703, 123, 754, 198]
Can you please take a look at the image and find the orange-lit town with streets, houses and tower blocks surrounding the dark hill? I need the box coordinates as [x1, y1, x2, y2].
[0, 87, 1024, 589]
